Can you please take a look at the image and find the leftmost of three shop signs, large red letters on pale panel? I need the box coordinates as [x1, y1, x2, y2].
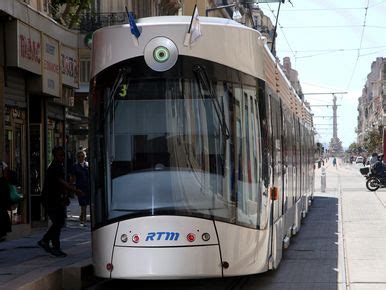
[17, 21, 42, 74]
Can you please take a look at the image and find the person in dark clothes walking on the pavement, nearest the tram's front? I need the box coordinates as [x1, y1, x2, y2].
[38, 146, 82, 257]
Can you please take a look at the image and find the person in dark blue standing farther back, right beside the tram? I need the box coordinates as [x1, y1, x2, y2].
[70, 150, 90, 227]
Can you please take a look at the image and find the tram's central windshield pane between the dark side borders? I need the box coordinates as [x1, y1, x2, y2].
[103, 75, 234, 221]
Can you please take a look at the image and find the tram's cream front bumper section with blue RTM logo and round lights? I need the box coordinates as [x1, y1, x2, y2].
[92, 216, 223, 279]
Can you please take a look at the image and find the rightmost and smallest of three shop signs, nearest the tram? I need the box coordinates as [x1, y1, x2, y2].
[60, 45, 79, 88]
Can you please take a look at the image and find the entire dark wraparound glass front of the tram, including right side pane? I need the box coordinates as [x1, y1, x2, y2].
[91, 57, 268, 228]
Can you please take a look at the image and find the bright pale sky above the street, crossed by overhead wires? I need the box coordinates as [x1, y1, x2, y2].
[259, 0, 386, 148]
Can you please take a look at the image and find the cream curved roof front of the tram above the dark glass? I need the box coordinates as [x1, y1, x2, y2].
[92, 16, 264, 78]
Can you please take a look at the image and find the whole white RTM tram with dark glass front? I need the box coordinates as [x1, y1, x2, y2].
[90, 16, 314, 279]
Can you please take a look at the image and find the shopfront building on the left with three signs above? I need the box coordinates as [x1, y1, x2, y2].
[0, 0, 79, 231]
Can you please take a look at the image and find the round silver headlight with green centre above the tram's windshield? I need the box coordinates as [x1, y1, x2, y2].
[144, 37, 178, 72]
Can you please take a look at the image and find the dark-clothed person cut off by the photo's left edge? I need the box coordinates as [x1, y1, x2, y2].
[0, 161, 12, 241]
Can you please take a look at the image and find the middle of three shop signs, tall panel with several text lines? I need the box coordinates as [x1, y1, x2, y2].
[42, 34, 60, 97]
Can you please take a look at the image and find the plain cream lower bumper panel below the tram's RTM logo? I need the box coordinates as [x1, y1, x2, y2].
[111, 245, 222, 279]
